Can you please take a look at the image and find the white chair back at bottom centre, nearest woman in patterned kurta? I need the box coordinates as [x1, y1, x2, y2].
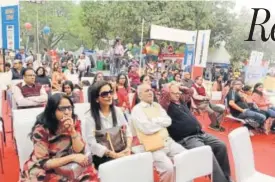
[98, 152, 154, 182]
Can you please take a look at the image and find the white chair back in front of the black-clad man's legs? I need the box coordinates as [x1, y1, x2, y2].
[174, 146, 213, 182]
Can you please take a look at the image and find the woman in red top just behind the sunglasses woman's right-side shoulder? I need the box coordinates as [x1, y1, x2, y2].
[117, 73, 131, 111]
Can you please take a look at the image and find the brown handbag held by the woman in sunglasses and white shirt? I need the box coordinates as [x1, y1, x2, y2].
[95, 126, 127, 153]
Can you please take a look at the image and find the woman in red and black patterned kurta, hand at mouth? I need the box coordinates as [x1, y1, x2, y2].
[21, 94, 98, 182]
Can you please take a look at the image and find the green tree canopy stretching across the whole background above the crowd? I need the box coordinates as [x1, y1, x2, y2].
[20, 1, 275, 64]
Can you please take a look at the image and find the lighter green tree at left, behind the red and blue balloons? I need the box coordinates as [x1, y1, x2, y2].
[20, 1, 92, 50]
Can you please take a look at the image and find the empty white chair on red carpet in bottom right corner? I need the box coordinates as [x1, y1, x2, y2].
[228, 127, 275, 182]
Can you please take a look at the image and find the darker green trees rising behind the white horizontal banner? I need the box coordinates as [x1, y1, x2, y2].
[81, 1, 234, 49]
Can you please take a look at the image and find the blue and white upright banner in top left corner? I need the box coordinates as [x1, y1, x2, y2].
[1, 5, 20, 50]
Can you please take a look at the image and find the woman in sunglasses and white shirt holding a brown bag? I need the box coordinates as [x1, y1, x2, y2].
[85, 81, 132, 169]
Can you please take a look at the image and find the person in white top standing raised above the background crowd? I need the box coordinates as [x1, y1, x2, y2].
[113, 37, 124, 75]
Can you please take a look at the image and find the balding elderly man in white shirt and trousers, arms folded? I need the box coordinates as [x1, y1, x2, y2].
[132, 84, 188, 182]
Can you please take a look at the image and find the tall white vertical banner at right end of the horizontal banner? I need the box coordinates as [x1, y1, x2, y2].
[195, 30, 211, 67]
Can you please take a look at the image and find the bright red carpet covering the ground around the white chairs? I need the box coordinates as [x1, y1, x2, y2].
[0, 98, 275, 182]
